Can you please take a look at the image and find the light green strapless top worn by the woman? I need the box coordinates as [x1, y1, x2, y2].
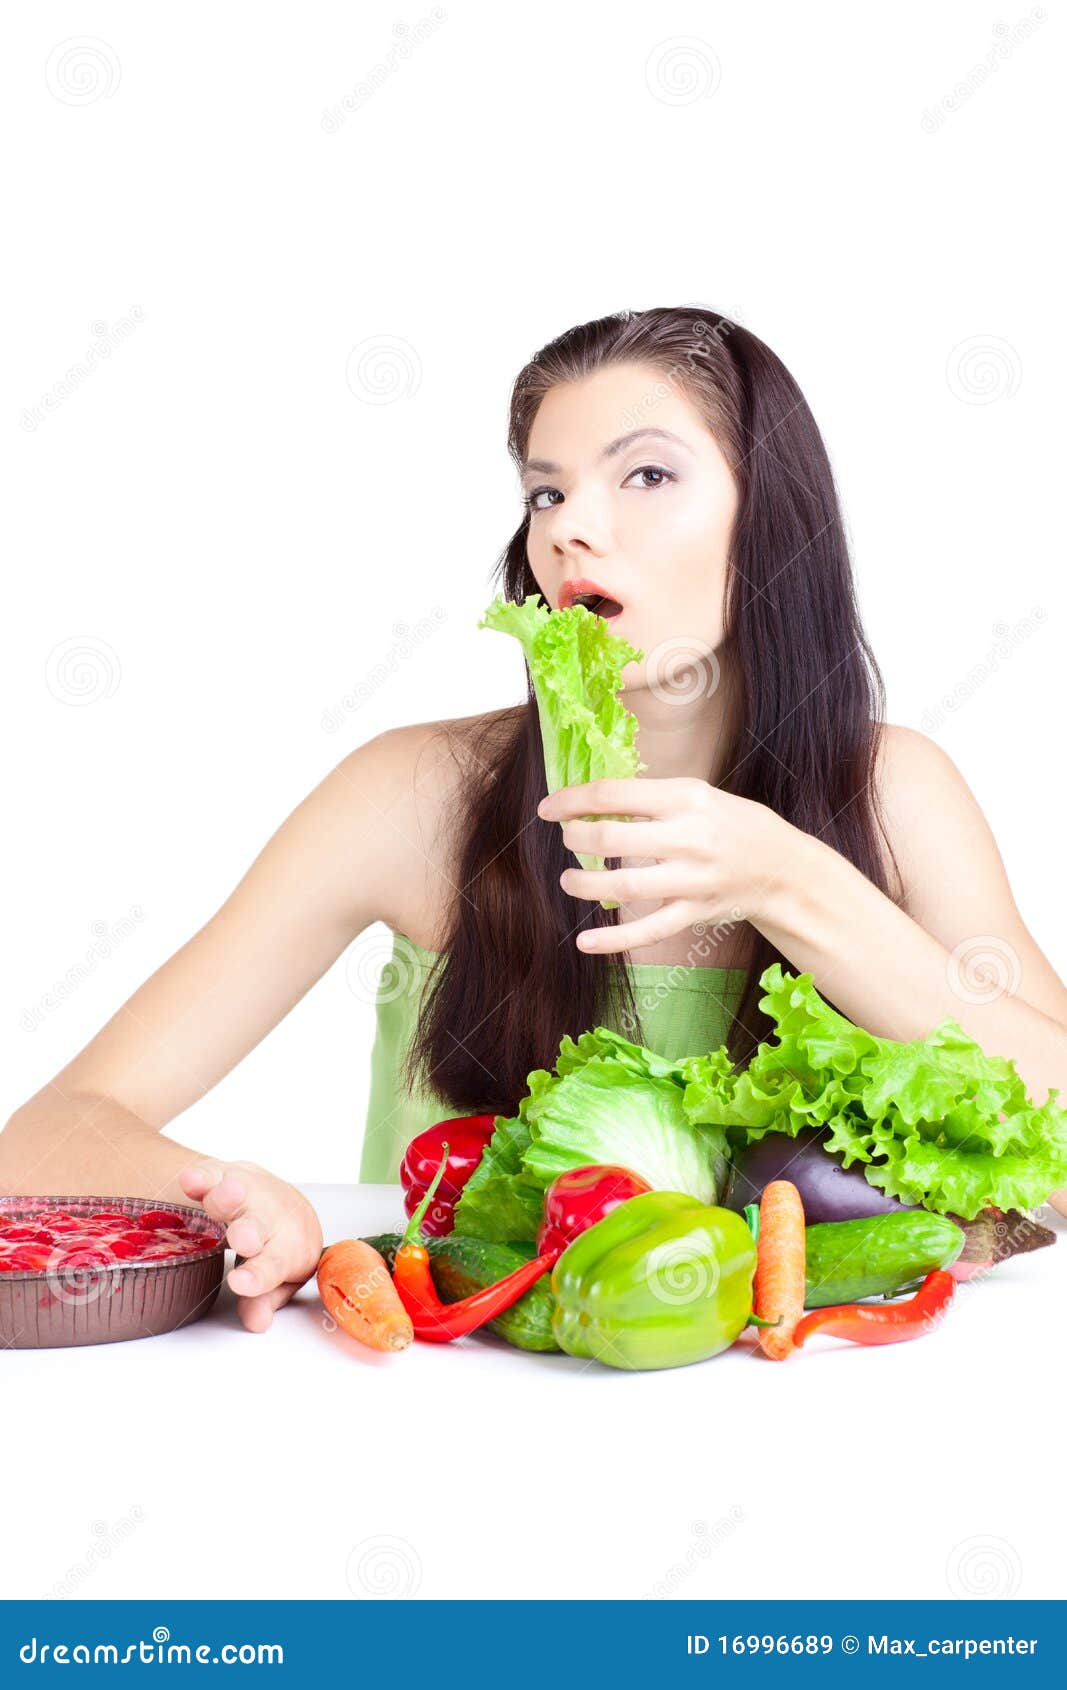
[360, 933, 744, 1185]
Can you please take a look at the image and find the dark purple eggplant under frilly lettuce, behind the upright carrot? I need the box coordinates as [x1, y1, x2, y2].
[719, 1127, 915, 1225]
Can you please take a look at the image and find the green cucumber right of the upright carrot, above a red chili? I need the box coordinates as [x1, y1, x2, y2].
[803, 1208, 964, 1308]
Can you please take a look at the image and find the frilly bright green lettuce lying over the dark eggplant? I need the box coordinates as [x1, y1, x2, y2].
[685, 963, 1067, 1220]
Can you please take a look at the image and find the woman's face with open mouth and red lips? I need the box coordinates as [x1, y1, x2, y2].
[523, 363, 737, 690]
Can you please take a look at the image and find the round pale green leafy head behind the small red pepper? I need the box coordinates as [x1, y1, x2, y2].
[455, 1028, 727, 1242]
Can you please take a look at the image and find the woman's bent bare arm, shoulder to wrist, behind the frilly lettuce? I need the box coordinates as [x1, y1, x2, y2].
[756, 728, 1067, 1102]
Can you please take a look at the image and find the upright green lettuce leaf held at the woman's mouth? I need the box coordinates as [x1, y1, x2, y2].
[479, 593, 648, 909]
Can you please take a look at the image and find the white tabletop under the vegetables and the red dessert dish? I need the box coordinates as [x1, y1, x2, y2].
[0, 1185, 1067, 1599]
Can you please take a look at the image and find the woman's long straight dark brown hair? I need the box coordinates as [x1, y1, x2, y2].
[406, 308, 891, 1114]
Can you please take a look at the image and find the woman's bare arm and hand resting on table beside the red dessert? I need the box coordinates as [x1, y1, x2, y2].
[0, 727, 439, 1330]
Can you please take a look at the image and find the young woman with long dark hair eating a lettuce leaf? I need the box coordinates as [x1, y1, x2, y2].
[0, 309, 1067, 1332]
